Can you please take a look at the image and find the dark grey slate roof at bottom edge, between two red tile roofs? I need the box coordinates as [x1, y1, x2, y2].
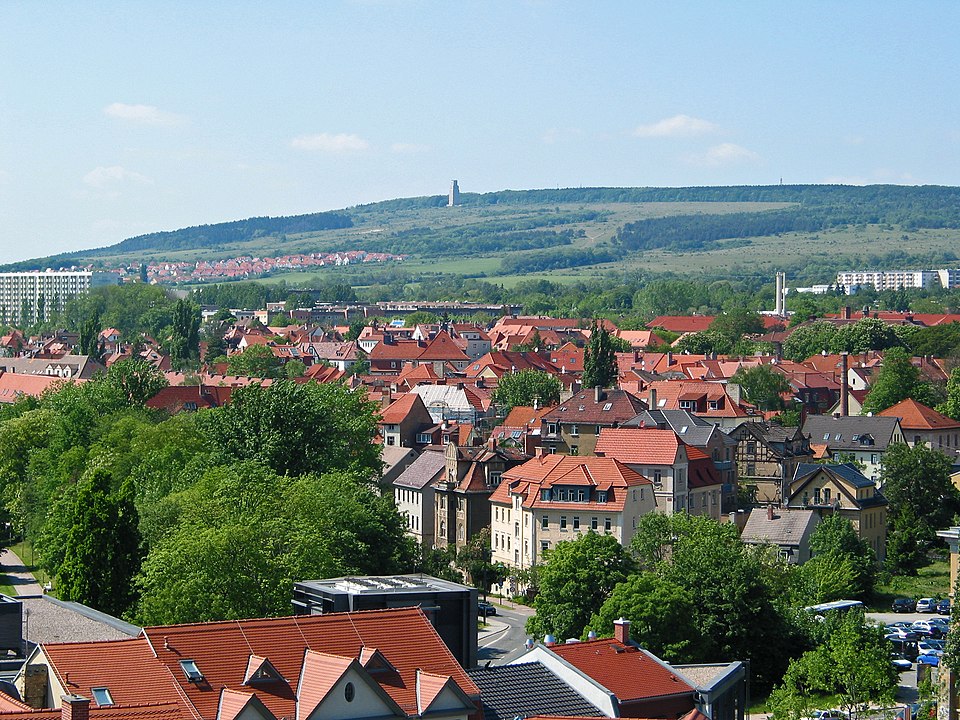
[467, 662, 603, 720]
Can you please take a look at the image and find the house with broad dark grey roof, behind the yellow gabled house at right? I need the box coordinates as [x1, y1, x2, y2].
[803, 415, 907, 483]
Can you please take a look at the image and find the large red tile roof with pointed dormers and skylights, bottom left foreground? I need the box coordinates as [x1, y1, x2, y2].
[42, 608, 479, 720]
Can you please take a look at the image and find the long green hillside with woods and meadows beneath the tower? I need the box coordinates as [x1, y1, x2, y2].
[7, 185, 960, 284]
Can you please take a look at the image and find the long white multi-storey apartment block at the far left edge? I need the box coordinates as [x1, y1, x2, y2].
[0, 270, 119, 323]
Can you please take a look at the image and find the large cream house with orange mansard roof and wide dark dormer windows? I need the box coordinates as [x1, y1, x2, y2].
[490, 455, 657, 589]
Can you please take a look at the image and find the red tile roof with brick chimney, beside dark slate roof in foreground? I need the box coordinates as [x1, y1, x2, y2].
[551, 639, 693, 703]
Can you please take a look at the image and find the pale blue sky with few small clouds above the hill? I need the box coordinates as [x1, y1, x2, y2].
[0, 0, 960, 262]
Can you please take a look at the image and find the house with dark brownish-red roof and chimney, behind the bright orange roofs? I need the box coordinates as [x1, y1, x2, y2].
[540, 388, 647, 455]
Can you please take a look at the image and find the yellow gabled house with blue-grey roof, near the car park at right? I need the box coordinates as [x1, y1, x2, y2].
[785, 463, 887, 562]
